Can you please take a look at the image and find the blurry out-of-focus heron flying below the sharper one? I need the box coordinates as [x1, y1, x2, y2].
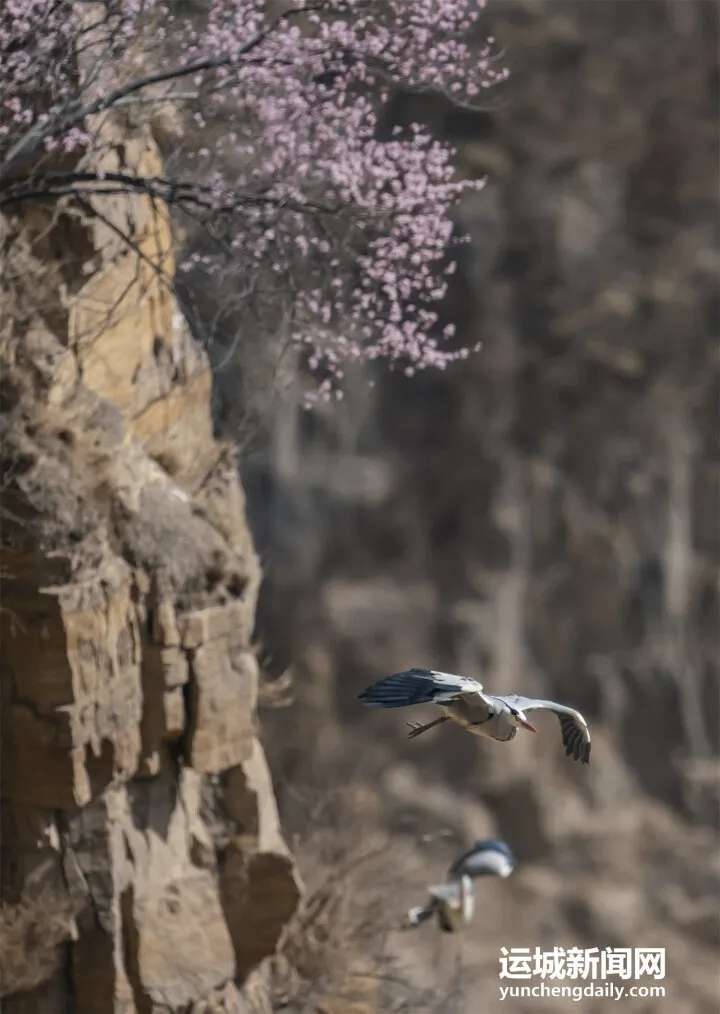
[403, 839, 515, 933]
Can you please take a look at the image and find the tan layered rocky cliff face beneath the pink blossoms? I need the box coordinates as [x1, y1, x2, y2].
[0, 130, 300, 1014]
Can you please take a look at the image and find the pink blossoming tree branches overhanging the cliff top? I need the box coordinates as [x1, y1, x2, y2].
[0, 0, 504, 397]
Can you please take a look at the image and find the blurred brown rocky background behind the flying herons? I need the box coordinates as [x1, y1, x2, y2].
[228, 0, 720, 1014]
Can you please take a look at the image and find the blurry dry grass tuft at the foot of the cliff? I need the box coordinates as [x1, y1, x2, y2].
[245, 800, 468, 1014]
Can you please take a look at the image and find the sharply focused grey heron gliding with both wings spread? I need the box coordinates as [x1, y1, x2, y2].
[359, 669, 590, 764]
